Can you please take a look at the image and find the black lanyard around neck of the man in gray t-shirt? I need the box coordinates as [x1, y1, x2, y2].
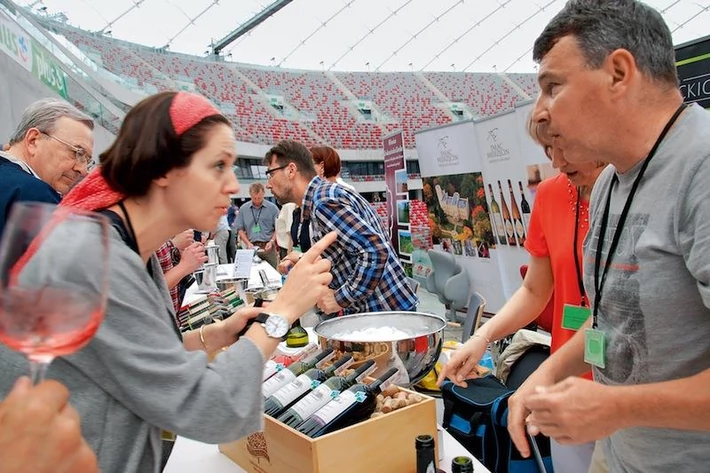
[592, 104, 686, 328]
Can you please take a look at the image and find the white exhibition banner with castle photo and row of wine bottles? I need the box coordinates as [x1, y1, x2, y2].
[413, 103, 555, 312]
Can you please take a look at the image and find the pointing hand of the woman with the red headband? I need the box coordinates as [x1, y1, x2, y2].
[269, 232, 337, 323]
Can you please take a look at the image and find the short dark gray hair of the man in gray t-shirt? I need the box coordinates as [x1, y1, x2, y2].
[533, 0, 678, 87]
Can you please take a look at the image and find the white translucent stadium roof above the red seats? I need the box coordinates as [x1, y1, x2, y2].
[17, 0, 710, 72]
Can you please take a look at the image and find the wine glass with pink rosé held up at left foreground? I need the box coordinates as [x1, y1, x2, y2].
[0, 202, 109, 384]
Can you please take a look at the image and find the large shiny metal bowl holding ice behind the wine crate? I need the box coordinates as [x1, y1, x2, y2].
[313, 312, 446, 387]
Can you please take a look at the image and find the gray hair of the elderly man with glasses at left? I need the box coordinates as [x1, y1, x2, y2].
[10, 98, 94, 145]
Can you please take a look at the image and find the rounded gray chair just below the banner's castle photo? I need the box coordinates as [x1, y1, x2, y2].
[426, 250, 471, 322]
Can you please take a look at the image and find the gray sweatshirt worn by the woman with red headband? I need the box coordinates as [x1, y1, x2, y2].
[0, 228, 264, 473]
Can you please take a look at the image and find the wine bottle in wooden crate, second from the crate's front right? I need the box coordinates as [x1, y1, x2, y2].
[278, 360, 376, 429]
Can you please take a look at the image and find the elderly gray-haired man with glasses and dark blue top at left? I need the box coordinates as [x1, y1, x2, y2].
[0, 99, 94, 236]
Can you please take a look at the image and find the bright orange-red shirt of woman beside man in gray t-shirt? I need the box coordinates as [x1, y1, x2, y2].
[525, 174, 589, 376]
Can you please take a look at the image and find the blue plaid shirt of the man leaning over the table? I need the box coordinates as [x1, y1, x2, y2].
[301, 176, 418, 314]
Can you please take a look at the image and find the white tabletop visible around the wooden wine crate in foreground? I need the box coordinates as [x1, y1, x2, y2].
[163, 431, 490, 473]
